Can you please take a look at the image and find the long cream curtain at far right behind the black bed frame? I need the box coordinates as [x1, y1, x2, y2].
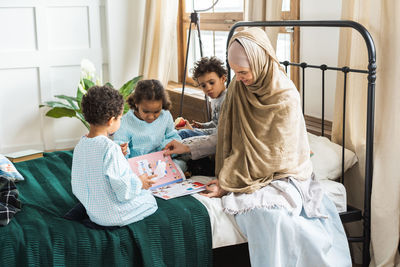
[333, 0, 400, 266]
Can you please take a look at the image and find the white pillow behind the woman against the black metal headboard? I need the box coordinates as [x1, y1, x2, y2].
[308, 133, 358, 180]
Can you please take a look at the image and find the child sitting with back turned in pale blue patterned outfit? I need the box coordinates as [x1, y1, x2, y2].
[71, 86, 157, 226]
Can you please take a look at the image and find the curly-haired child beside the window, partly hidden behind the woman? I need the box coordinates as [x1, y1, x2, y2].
[177, 57, 227, 139]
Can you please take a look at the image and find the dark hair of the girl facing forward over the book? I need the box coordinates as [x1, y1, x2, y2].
[127, 79, 171, 111]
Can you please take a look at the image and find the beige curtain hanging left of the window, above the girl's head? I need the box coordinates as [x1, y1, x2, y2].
[139, 0, 179, 86]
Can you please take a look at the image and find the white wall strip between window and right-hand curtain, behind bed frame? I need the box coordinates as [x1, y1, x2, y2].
[300, 0, 342, 121]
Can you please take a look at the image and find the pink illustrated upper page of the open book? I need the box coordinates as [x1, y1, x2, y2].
[128, 151, 185, 190]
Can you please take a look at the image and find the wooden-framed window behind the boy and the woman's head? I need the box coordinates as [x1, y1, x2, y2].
[178, 0, 299, 85]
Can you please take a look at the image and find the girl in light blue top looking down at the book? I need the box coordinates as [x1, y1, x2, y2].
[114, 80, 186, 171]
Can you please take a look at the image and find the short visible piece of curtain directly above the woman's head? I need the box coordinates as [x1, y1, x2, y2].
[244, 0, 282, 50]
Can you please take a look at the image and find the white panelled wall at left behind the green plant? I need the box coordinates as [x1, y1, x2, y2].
[0, 0, 108, 153]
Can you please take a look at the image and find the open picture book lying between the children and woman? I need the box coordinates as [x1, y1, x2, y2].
[128, 151, 205, 199]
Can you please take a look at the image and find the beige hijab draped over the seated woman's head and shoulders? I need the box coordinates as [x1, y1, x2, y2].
[216, 28, 312, 193]
